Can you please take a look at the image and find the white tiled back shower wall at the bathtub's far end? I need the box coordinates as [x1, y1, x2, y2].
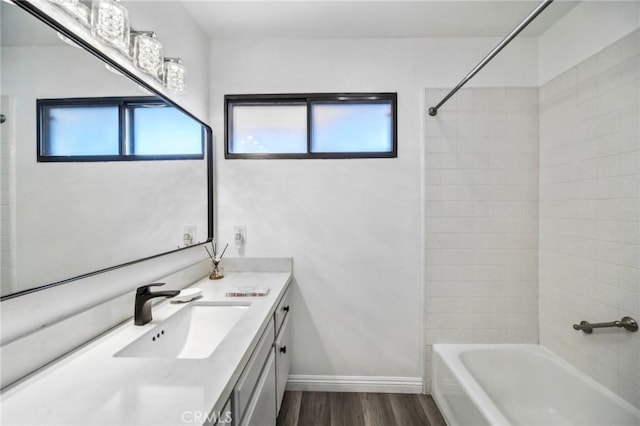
[424, 88, 538, 391]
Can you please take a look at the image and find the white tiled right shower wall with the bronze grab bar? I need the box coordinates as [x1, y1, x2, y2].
[540, 31, 640, 407]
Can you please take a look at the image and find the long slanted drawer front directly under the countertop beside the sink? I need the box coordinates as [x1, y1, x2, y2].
[233, 327, 275, 424]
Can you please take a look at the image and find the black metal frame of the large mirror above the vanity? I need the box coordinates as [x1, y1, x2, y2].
[0, 0, 214, 301]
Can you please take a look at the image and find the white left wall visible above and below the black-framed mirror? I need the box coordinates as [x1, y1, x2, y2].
[0, 2, 209, 387]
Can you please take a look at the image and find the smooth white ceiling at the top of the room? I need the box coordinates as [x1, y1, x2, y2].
[183, 0, 578, 39]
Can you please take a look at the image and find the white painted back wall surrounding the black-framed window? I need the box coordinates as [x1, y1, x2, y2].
[210, 38, 537, 390]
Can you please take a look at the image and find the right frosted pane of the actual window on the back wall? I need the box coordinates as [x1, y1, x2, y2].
[311, 102, 393, 152]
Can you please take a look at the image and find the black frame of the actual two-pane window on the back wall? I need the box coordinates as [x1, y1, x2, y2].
[224, 92, 398, 159]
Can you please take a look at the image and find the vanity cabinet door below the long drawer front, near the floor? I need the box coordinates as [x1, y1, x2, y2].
[242, 349, 276, 426]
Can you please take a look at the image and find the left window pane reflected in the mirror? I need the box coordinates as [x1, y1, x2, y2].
[42, 106, 120, 156]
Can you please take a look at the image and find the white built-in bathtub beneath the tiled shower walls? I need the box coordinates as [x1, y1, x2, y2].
[432, 344, 640, 426]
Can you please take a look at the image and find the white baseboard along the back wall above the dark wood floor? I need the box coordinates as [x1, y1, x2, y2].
[286, 374, 423, 393]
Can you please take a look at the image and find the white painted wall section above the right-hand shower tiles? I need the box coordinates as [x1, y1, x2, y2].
[538, 0, 640, 85]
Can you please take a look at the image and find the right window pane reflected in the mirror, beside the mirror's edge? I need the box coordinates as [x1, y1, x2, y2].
[133, 104, 203, 155]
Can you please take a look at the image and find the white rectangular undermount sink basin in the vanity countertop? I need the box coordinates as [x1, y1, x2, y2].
[114, 302, 249, 359]
